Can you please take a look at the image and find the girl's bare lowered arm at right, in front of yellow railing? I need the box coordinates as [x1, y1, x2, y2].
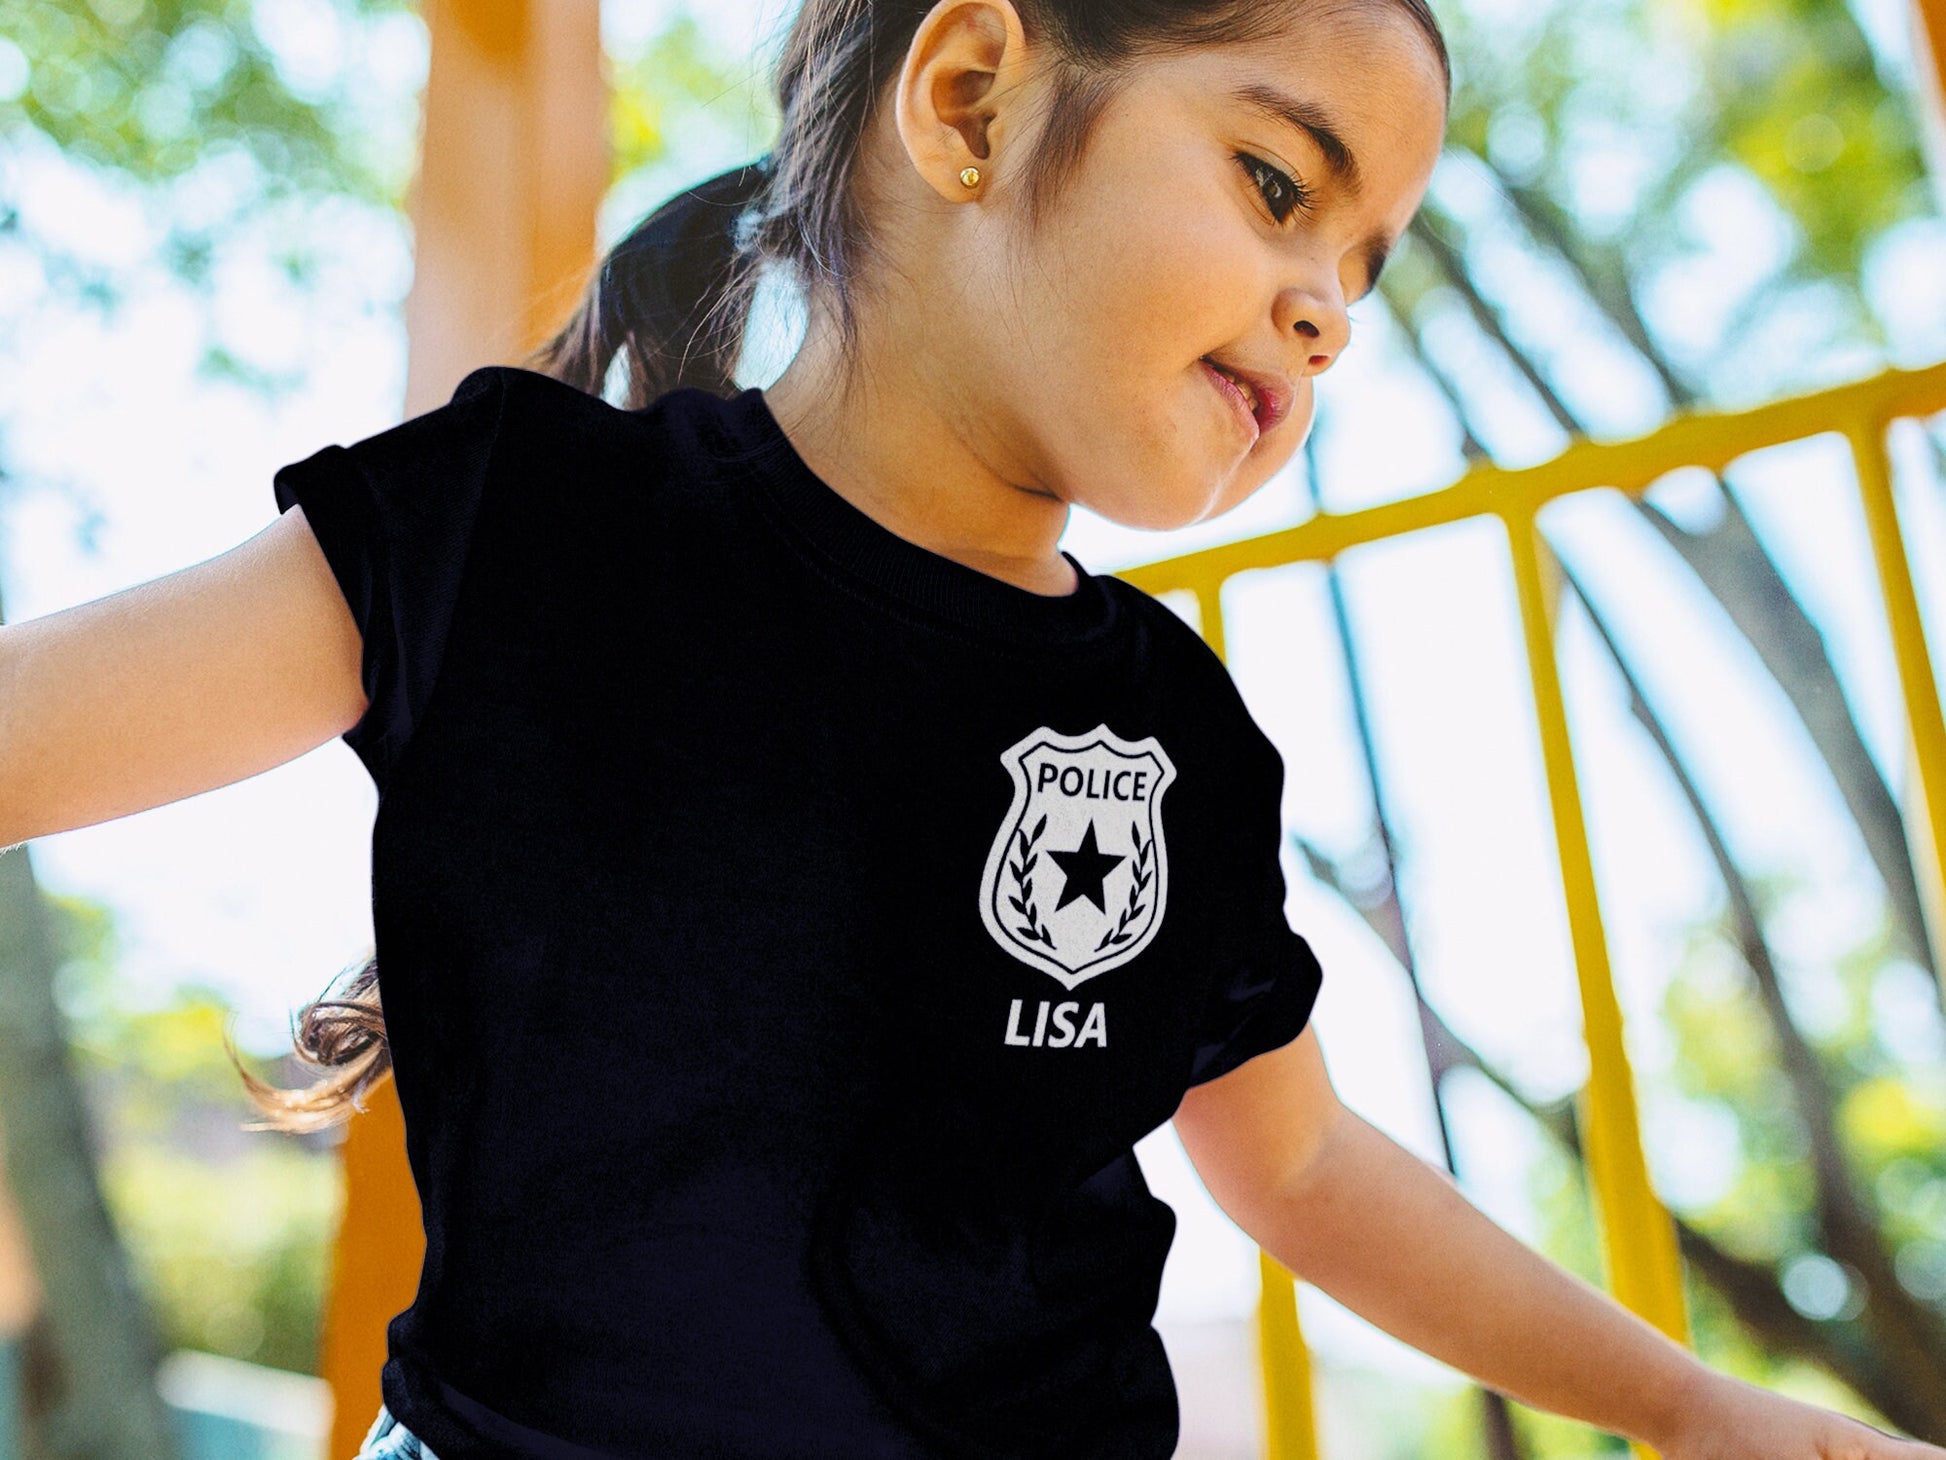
[1175, 1028, 1946, 1460]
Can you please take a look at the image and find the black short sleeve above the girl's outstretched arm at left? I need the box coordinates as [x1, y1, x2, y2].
[272, 366, 508, 794]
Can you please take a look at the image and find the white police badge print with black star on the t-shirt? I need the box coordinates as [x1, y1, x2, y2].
[979, 724, 1175, 1004]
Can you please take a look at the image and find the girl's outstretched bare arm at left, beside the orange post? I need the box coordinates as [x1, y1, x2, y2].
[0, 506, 366, 849]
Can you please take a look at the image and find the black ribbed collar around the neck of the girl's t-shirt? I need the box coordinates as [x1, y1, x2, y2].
[718, 385, 1119, 648]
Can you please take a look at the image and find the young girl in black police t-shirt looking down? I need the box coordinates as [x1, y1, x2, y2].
[0, 0, 1946, 1460]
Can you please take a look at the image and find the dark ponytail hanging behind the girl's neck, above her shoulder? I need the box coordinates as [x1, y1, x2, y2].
[522, 154, 771, 409]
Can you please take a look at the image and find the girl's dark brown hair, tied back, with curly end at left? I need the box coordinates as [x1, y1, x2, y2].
[232, 0, 1452, 1129]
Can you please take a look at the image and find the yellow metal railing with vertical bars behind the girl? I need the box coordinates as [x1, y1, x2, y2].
[1117, 364, 1946, 1460]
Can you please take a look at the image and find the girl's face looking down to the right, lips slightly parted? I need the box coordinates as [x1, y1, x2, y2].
[895, 4, 1446, 529]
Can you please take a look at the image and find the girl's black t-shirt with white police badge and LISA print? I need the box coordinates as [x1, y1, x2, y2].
[274, 366, 1321, 1460]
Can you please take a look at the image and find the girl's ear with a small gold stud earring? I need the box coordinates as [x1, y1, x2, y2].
[893, 0, 1029, 202]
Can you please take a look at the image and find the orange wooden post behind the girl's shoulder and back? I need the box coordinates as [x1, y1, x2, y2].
[323, 0, 609, 1460]
